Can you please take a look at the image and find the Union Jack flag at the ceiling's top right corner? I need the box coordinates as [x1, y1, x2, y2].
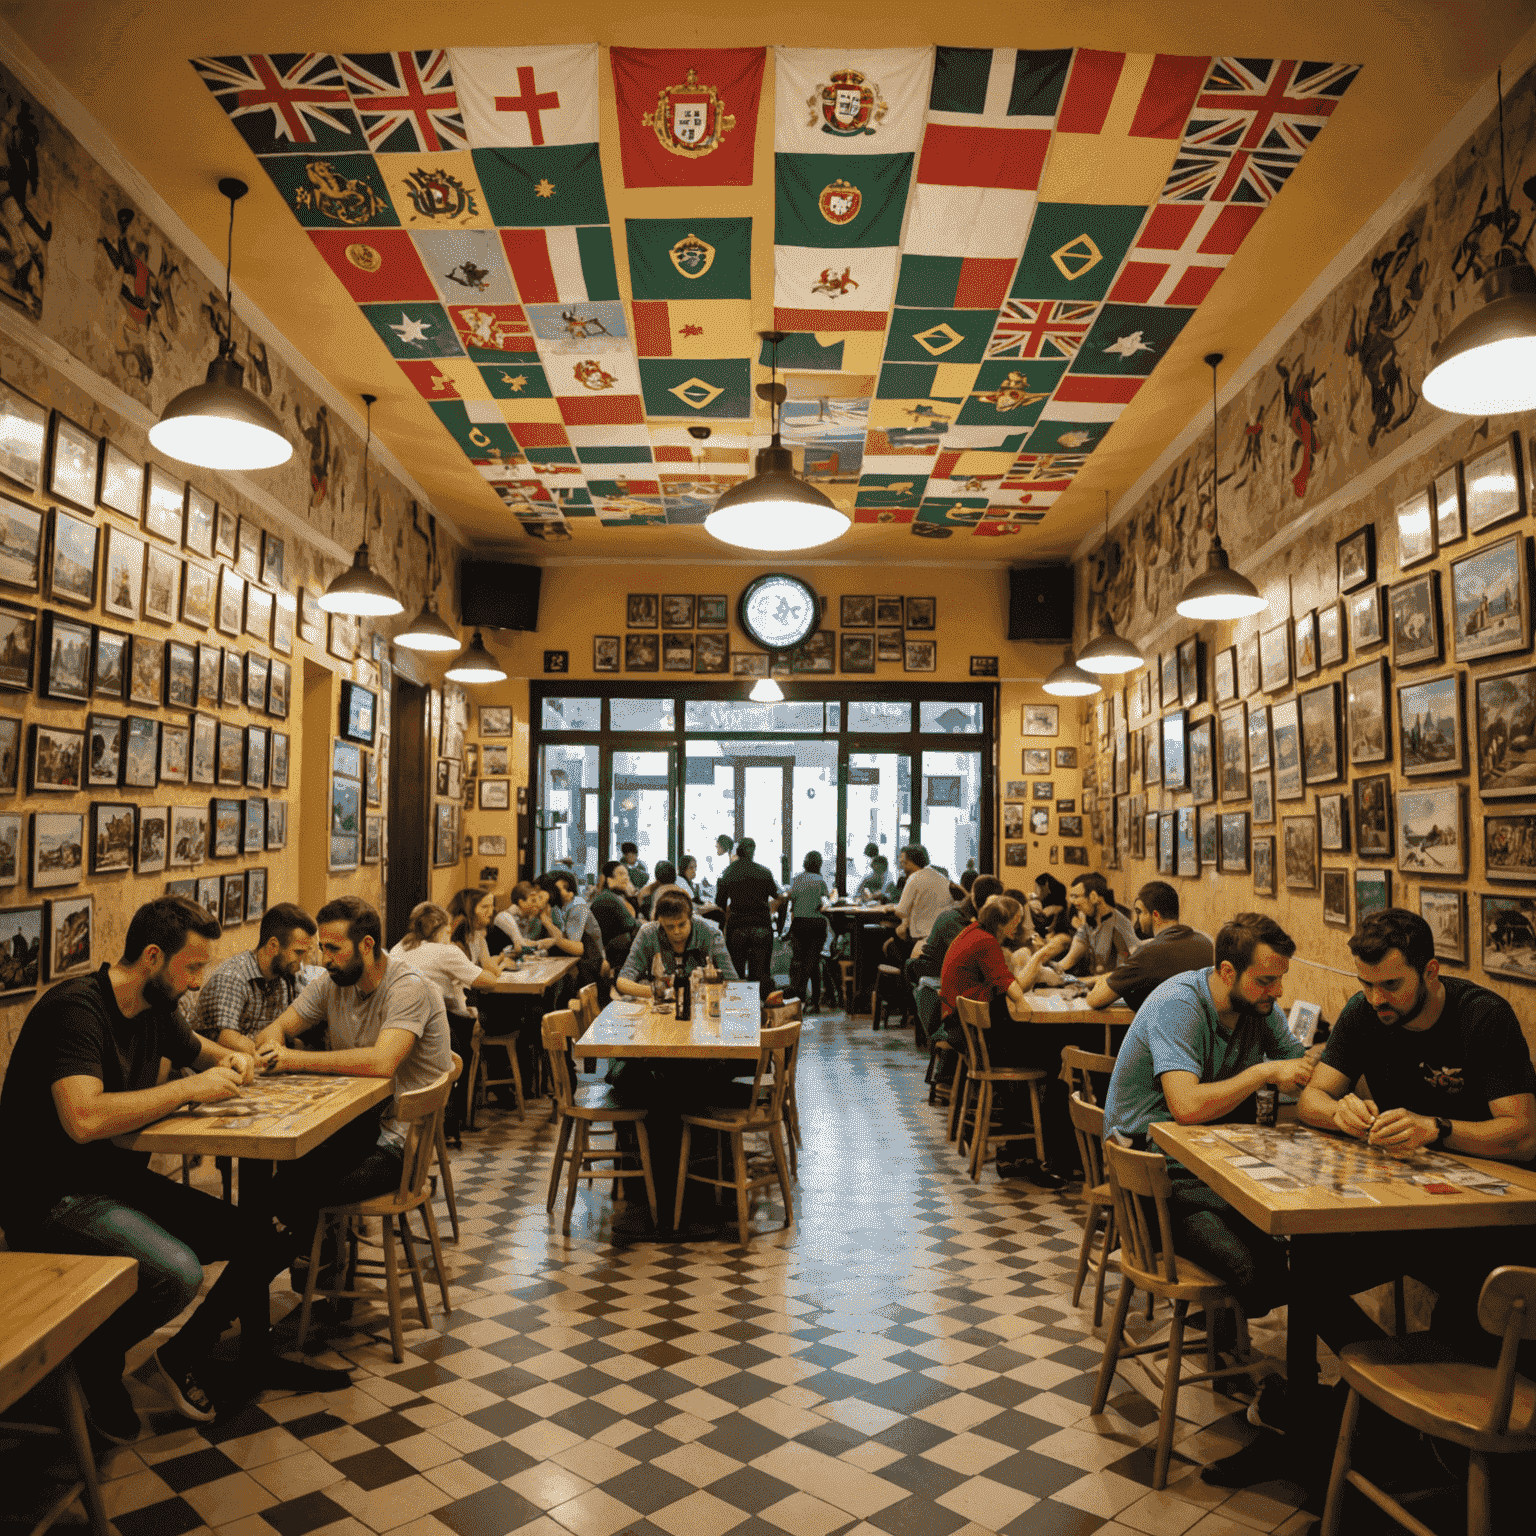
[1163, 58, 1359, 203]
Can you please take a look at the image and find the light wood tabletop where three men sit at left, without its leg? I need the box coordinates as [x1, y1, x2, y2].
[114, 1072, 395, 1163]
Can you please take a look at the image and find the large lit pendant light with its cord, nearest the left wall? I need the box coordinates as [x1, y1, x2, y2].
[149, 177, 293, 470]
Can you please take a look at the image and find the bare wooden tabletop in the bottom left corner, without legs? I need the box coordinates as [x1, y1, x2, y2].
[0, 1253, 138, 1409]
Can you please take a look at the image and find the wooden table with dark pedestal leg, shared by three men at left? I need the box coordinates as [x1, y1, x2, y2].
[114, 1072, 395, 1392]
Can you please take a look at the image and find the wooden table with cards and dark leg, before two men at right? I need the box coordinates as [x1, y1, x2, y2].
[1150, 1121, 1536, 1422]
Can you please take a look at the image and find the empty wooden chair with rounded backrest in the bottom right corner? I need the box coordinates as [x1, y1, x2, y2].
[1322, 1259, 1536, 1536]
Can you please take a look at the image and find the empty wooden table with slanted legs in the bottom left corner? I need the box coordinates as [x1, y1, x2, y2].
[0, 1253, 138, 1536]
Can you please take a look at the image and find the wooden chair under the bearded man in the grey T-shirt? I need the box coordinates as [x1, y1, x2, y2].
[298, 1057, 462, 1364]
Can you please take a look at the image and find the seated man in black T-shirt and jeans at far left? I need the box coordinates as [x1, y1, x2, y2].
[0, 895, 272, 1444]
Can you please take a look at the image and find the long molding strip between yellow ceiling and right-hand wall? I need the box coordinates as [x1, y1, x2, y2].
[1071, 13, 1536, 565]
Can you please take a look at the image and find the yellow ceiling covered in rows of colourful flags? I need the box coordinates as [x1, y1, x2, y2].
[0, 0, 1530, 561]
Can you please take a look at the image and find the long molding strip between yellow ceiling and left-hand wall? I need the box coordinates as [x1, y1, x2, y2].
[0, 18, 470, 552]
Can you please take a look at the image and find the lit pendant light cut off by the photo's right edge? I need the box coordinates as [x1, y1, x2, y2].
[1422, 69, 1536, 416]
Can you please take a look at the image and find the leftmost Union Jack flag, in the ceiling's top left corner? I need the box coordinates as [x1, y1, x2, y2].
[192, 54, 364, 154]
